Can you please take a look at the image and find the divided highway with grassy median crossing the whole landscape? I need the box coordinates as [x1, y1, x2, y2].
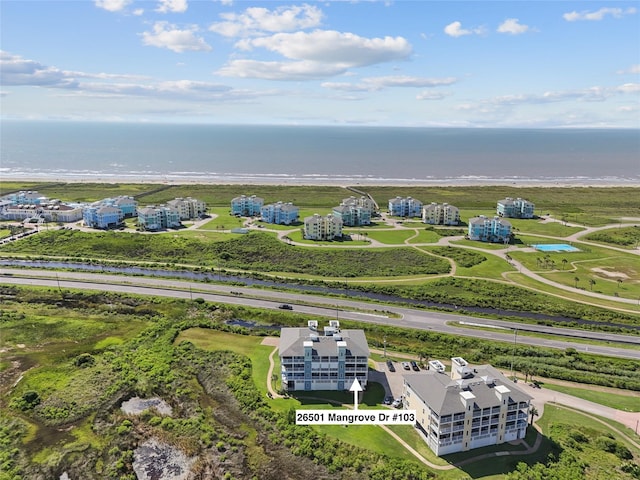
[0, 268, 640, 360]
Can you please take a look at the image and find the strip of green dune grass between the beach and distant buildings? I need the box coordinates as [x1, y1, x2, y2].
[6, 182, 638, 218]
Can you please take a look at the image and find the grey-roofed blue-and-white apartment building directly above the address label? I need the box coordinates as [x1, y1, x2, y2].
[279, 320, 369, 391]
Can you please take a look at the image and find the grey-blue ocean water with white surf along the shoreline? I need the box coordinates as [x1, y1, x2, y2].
[0, 121, 640, 185]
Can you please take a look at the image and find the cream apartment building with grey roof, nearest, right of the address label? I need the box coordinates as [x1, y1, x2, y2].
[403, 357, 532, 456]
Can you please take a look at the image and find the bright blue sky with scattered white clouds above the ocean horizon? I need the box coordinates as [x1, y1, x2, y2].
[0, 0, 640, 128]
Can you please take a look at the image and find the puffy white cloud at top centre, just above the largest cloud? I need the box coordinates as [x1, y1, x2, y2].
[209, 4, 322, 37]
